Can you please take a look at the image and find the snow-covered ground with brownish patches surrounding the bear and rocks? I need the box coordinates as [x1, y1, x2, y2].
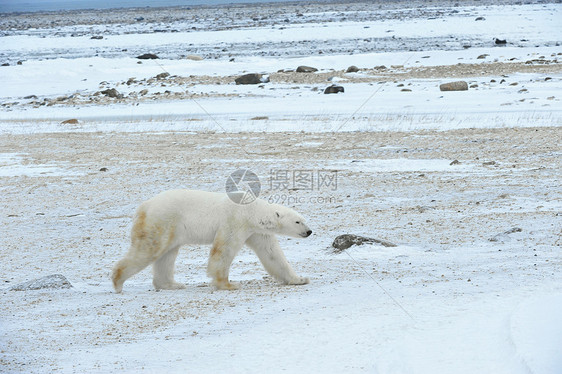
[0, 1, 562, 374]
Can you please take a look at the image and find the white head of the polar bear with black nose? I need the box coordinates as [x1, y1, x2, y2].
[259, 204, 312, 238]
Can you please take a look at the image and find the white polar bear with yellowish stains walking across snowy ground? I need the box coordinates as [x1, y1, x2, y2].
[112, 190, 312, 293]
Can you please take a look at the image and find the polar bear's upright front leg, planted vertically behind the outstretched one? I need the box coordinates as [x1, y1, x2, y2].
[203, 231, 244, 291]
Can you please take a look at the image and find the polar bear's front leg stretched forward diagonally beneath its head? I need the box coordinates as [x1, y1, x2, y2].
[246, 234, 310, 285]
